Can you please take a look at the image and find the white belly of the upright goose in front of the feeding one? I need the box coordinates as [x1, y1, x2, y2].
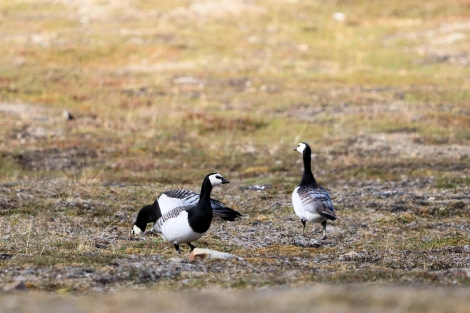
[160, 211, 203, 244]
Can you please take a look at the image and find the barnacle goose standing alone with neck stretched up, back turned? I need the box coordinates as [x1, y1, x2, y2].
[292, 142, 336, 240]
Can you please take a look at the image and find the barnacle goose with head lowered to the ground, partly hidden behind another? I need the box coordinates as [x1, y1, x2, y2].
[131, 185, 242, 235]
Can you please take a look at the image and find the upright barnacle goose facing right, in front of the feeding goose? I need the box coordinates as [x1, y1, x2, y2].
[152, 173, 228, 252]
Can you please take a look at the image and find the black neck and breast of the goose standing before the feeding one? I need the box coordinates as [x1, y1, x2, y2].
[188, 177, 212, 233]
